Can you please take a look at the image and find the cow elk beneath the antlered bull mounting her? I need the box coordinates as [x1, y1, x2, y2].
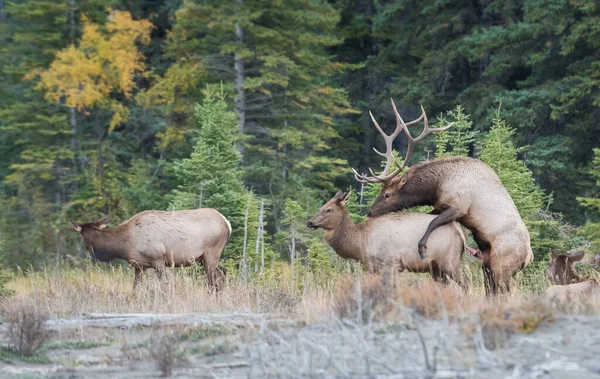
[306, 191, 465, 281]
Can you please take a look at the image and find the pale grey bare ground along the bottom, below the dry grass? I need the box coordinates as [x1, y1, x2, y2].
[0, 313, 600, 378]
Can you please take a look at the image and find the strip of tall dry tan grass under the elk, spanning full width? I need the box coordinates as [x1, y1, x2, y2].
[7, 264, 600, 329]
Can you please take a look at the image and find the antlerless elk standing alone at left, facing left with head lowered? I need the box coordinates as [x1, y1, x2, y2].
[71, 208, 231, 290]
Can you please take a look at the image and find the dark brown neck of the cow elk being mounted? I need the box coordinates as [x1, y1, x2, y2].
[325, 211, 367, 264]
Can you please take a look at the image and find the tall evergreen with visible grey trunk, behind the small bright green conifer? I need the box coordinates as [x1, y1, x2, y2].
[162, 0, 352, 229]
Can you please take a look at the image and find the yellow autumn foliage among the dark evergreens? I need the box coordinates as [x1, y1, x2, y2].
[37, 9, 154, 132]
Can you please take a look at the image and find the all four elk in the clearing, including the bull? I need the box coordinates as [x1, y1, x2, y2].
[71, 101, 600, 299]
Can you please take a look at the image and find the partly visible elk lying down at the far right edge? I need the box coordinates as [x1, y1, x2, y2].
[546, 250, 600, 302]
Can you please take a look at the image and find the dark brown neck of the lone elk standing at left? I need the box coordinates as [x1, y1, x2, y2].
[84, 227, 129, 262]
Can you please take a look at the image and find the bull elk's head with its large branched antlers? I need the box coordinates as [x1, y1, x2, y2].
[352, 100, 452, 217]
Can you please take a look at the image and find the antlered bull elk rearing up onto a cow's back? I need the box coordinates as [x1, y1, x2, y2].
[354, 101, 533, 294]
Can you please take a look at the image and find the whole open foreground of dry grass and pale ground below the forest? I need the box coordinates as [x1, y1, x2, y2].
[0, 260, 600, 378]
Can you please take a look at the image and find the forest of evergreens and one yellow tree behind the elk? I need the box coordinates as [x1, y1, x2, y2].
[0, 0, 600, 275]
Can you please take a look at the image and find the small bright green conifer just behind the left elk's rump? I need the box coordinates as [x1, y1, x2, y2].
[169, 89, 258, 263]
